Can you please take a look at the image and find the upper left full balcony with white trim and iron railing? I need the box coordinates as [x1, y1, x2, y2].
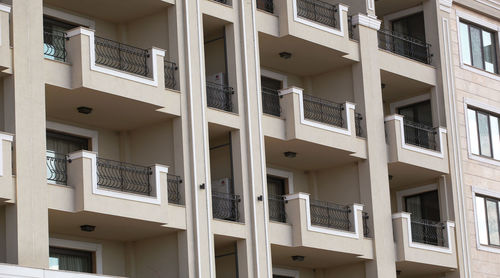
[44, 27, 180, 116]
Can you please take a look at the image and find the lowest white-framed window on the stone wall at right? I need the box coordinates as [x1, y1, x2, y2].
[475, 195, 500, 247]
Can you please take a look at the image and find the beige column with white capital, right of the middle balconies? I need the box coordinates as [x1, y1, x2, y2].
[353, 14, 396, 278]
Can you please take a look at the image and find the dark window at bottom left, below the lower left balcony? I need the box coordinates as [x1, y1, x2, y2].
[49, 247, 95, 273]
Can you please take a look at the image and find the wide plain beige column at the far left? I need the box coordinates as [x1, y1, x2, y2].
[4, 0, 49, 267]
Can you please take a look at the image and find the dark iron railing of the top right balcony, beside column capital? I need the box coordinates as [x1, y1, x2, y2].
[378, 29, 432, 64]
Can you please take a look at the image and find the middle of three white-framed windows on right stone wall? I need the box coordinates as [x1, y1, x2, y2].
[467, 108, 500, 160]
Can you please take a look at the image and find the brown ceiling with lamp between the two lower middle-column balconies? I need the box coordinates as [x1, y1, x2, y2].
[265, 137, 359, 171]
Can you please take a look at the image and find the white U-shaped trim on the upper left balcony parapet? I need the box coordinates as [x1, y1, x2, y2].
[67, 27, 165, 87]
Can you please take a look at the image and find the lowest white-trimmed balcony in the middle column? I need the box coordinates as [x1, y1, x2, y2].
[269, 193, 374, 268]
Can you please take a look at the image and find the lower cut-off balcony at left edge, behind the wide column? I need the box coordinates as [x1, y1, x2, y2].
[0, 132, 16, 203]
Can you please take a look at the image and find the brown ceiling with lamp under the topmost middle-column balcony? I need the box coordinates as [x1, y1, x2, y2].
[259, 33, 354, 76]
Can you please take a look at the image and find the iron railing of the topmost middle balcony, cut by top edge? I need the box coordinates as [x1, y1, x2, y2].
[297, 0, 337, 28]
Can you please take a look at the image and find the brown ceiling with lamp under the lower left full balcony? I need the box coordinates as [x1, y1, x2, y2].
[49, 210, 177, 241]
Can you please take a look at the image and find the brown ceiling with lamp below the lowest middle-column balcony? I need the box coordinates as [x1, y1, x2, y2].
[271, 245, 364, 269]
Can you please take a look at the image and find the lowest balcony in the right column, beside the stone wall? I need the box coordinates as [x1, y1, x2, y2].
[392, 212, 458, 277]
